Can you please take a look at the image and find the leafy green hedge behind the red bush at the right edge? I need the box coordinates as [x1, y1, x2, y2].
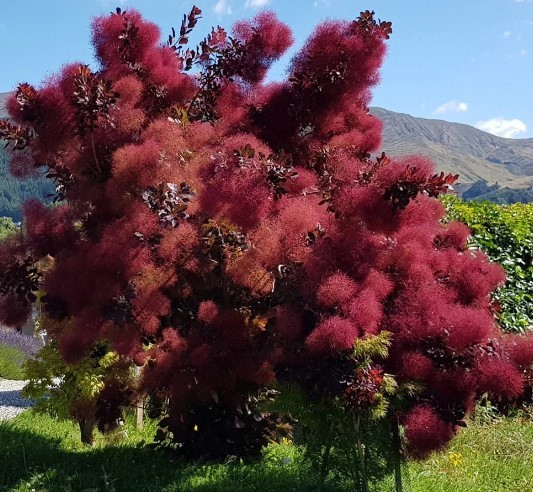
[443, 196, 533, 332]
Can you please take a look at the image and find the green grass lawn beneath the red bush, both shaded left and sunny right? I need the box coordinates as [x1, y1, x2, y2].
[0, 411, 533, 492]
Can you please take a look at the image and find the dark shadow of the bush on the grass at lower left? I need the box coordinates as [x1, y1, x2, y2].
[0, 420, 342, 492]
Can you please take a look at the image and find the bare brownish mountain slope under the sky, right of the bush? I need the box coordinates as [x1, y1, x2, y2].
[370, 108, 533, 196]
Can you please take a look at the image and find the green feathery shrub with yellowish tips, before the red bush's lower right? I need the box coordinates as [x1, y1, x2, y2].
[272, 331, 408, 492]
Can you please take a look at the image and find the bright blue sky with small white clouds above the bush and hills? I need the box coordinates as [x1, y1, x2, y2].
[0, 0, 533, 138]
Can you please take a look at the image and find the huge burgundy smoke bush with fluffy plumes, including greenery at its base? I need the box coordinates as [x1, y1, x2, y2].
[0, 7, 533, 491]
